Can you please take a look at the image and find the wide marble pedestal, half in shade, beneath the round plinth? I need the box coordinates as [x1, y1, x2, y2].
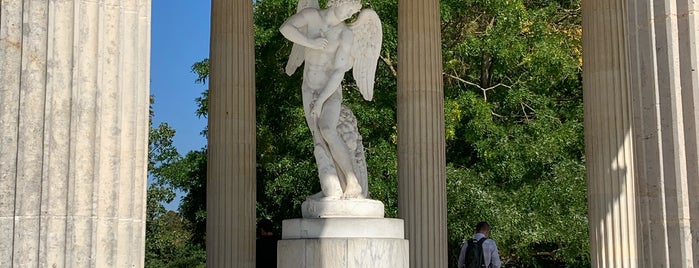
[277, 218, 409, 268]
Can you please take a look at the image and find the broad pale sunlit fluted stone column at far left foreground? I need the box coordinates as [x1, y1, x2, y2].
[0, 0, 150, 267]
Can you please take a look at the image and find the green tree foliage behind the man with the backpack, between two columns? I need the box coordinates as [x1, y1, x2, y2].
[441, 0, 589, 267]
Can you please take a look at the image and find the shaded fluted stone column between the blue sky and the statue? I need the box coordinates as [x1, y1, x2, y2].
[206, 0, 256, 267]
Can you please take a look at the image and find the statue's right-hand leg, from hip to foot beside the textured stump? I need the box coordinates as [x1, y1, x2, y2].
[318, 91, 362, 198]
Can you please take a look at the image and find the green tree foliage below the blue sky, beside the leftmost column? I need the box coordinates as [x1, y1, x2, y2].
[145, 97, 206, 268]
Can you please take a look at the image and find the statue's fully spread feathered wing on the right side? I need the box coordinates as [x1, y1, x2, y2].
[349, 9, 383, 100]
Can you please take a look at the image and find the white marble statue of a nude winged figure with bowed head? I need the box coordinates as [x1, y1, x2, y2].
[279, 0, 382, 199]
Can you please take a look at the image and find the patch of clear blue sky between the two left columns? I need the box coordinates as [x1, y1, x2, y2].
[150, 0, 211, 155]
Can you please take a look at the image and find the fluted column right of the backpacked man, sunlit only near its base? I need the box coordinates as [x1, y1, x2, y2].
[583, 0, 638, 268]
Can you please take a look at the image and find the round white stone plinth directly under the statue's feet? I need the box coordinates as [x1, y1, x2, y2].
[301, 198, 384, 218]
